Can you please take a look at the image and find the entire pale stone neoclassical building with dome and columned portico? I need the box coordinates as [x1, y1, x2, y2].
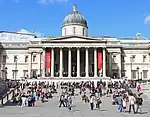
[0, 6, 150, 80]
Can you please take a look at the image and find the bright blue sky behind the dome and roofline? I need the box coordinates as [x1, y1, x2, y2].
[0, 0, 150, 38]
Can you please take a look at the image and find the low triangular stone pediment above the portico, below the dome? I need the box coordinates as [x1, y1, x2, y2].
[42, 36, 105, 42]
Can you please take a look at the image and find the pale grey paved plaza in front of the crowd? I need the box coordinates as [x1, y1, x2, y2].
[0, 89, 150, 117]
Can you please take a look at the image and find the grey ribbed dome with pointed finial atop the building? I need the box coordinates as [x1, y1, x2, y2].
[63, 5, 87, 27]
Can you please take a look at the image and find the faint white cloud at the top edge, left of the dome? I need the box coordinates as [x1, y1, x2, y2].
[39, 0, 69, 4]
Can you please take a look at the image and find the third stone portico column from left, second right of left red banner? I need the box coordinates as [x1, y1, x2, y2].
[59, 48, 63, 78]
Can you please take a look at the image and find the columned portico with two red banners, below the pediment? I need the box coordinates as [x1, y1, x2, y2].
[43, 47, 106, 78]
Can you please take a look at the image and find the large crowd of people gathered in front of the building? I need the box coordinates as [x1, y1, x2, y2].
[1, 81, 143, 113]
